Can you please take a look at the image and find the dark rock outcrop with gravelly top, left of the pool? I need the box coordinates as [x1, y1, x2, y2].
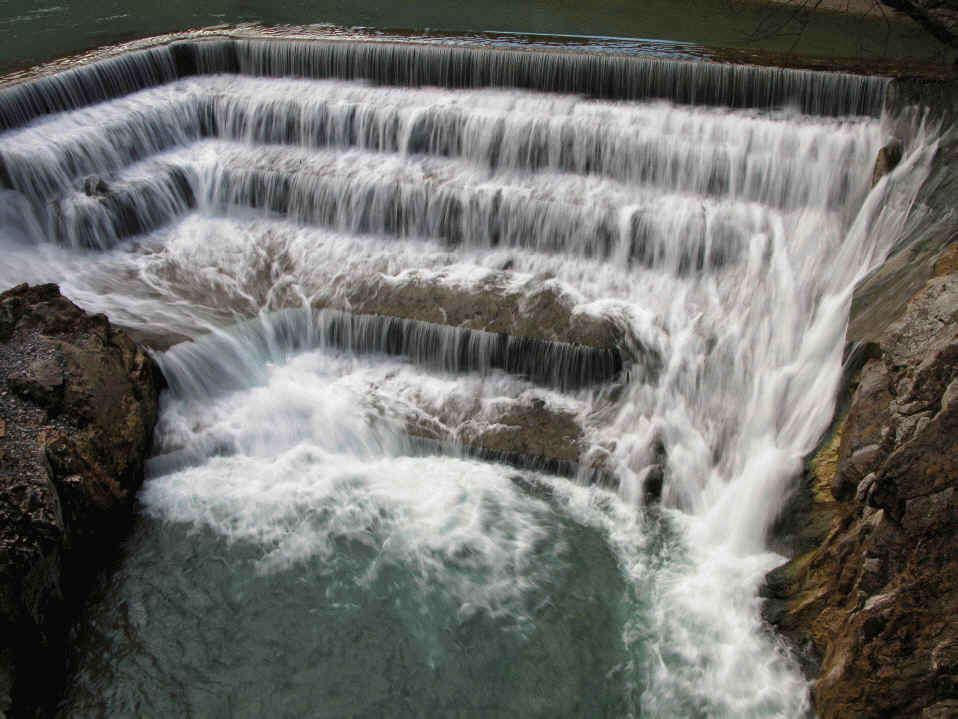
[0, 285, 162, 716]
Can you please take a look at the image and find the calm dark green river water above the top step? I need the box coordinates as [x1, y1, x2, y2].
[0, 0, 954, 71]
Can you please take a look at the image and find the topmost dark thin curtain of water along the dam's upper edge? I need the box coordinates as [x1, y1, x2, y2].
[0, 38, 885, 129]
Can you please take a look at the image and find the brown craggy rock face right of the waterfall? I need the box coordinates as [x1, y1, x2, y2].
[768, 242, 958, 719]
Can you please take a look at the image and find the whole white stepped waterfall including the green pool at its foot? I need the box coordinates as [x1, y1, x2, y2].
[0, 33, 933, 718]
